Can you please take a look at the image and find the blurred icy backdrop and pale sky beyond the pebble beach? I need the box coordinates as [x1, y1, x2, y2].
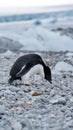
[0, 0, 73, 52]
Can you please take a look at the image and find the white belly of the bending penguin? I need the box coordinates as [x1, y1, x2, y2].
[22, 64, 44, 83]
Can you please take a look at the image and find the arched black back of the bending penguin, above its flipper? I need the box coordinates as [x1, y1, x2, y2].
[10, 54, 42, 76]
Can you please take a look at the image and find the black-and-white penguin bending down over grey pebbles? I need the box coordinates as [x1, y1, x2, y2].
[8, 54, 52, 84]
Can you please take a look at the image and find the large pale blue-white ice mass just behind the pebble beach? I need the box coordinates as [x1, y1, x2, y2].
[0, 22, 73, 51]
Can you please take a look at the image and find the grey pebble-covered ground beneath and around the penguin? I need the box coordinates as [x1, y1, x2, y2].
[0, 52, 73, 130]
